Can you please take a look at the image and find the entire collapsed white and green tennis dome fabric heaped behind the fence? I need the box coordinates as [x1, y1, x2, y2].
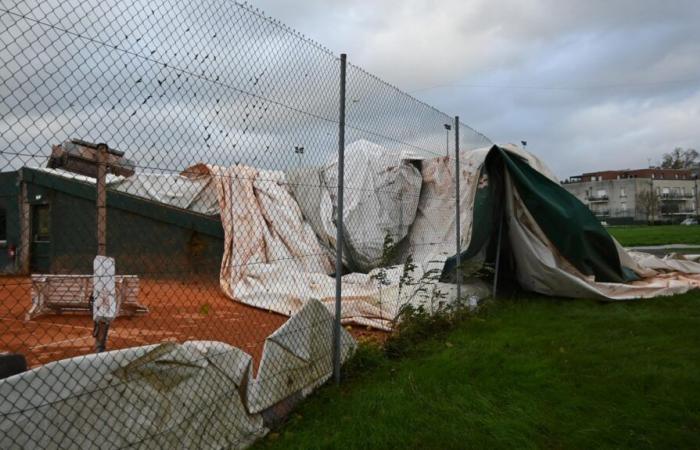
[178, 141, 700, 330]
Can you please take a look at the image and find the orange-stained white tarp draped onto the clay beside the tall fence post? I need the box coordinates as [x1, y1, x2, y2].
[188, 155, 460, 330]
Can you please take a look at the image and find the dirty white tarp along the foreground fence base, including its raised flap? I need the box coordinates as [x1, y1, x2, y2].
[0, 301, 356, 449]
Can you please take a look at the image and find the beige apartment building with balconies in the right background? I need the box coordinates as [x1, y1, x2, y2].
[562, 168, 698, 223]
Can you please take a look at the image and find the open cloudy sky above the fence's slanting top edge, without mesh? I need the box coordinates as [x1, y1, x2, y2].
[253, 0, 700, 177]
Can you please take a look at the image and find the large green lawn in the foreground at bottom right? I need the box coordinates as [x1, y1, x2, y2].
[258, 293, 700, 449]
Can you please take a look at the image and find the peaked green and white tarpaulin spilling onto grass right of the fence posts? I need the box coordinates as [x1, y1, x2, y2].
[456, 146, 700, 300]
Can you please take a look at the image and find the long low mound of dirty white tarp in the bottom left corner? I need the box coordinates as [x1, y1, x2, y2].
[0, 341, 266, 449]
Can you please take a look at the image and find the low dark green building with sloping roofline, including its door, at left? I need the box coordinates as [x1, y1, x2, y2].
[0, 168, 224, 279]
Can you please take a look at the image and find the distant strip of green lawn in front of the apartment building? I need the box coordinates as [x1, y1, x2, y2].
[607, 225, 700, 247]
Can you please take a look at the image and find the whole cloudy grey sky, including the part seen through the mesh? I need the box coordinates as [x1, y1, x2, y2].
[0, 0, 700, 176]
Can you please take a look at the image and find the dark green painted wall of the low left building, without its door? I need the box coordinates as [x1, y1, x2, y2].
[0, 169, 223, 279]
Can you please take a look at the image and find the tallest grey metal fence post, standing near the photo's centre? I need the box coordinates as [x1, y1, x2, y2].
[333, 53, 347, 384]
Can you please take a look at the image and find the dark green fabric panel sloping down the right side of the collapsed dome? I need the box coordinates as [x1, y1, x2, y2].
[492, 146, 627, 282]
